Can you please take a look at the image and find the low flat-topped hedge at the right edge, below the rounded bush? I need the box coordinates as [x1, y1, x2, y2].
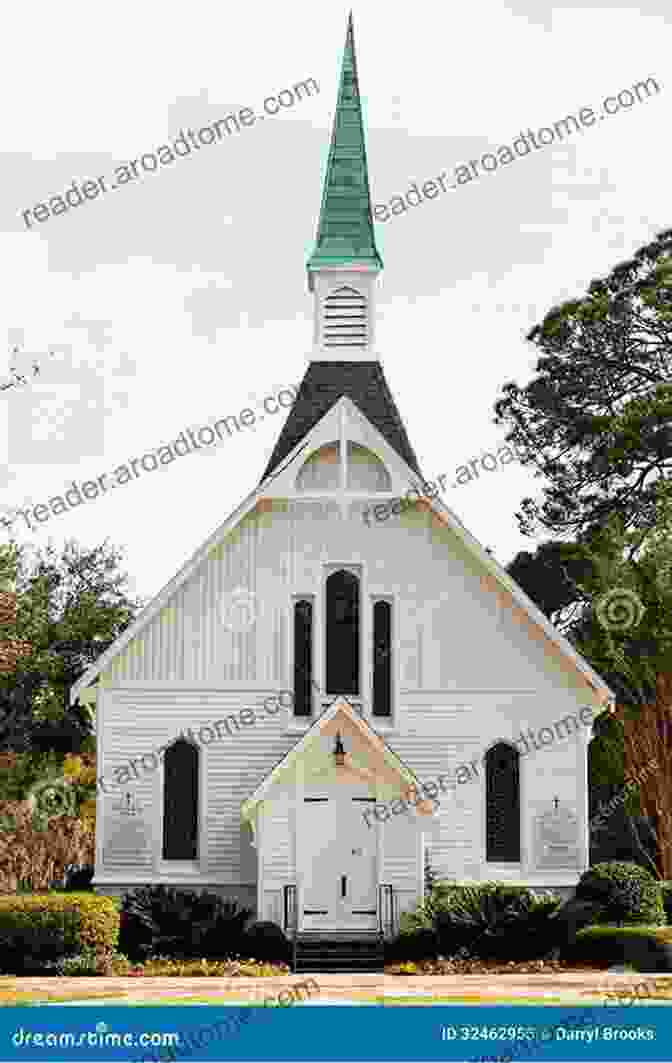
[561, 926, 672, 974]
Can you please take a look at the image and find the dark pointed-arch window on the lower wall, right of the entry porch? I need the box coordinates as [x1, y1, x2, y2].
[485, 742, 520, 863]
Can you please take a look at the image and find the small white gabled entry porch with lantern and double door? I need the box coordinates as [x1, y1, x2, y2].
[241, 702, 434, 956]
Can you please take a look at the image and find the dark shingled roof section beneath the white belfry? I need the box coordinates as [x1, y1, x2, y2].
[261, 361, 422, 484]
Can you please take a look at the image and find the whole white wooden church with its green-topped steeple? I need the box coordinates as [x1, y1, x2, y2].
[72, 12, 614, 956]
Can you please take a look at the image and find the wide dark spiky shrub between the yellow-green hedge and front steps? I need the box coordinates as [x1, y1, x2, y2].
[119, 885, 252, 959]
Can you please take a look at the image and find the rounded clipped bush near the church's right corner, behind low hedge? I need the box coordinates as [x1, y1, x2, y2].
[575, 862, 666, 926]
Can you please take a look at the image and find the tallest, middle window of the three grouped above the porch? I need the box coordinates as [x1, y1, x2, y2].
[326, 570, 359, 696]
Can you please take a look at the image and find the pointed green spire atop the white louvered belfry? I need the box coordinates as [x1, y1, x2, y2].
[307, 13, 383, 290]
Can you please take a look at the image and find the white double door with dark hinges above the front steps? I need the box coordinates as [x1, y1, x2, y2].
[300, 790, 377, 930]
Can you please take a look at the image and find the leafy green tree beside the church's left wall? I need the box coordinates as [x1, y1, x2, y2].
[0, 540, 142, 754]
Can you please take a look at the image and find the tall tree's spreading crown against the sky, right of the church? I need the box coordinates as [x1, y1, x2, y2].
[494, 230, 672, 538]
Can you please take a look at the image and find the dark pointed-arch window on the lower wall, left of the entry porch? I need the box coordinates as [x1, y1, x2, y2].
[163, 739, 199, 860]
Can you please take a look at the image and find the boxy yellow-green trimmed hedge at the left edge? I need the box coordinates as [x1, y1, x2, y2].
[0, 893, 119, 974]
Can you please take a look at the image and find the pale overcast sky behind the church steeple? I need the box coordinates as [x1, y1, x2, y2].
[0, 0, 672, 596]
